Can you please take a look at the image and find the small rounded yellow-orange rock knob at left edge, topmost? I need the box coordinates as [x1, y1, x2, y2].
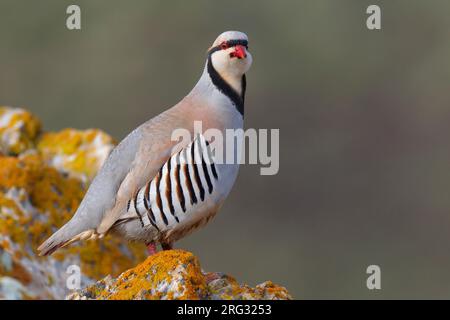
[0, 106, 41, 155]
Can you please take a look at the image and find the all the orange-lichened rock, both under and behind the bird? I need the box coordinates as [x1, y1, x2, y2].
[0, 107, 290, 299]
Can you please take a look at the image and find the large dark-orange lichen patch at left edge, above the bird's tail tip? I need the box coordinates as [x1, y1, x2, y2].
[0, 155, 83, 247]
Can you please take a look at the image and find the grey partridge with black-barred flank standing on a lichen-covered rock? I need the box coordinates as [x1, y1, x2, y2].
[38, 31, 253, 256]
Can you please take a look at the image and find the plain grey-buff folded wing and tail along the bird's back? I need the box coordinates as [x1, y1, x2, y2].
[38, 105, 192, 255]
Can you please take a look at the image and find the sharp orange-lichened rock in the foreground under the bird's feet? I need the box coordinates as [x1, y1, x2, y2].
[67, 250, 291, 300]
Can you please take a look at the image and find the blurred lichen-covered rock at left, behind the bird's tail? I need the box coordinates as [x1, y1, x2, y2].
[0, 108, 145, 299]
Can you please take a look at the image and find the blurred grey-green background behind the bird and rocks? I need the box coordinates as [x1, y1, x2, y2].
[0, 0, 450, 299]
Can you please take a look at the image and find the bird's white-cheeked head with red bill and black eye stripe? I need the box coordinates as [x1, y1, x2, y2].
[208, 31, 252, 80]
